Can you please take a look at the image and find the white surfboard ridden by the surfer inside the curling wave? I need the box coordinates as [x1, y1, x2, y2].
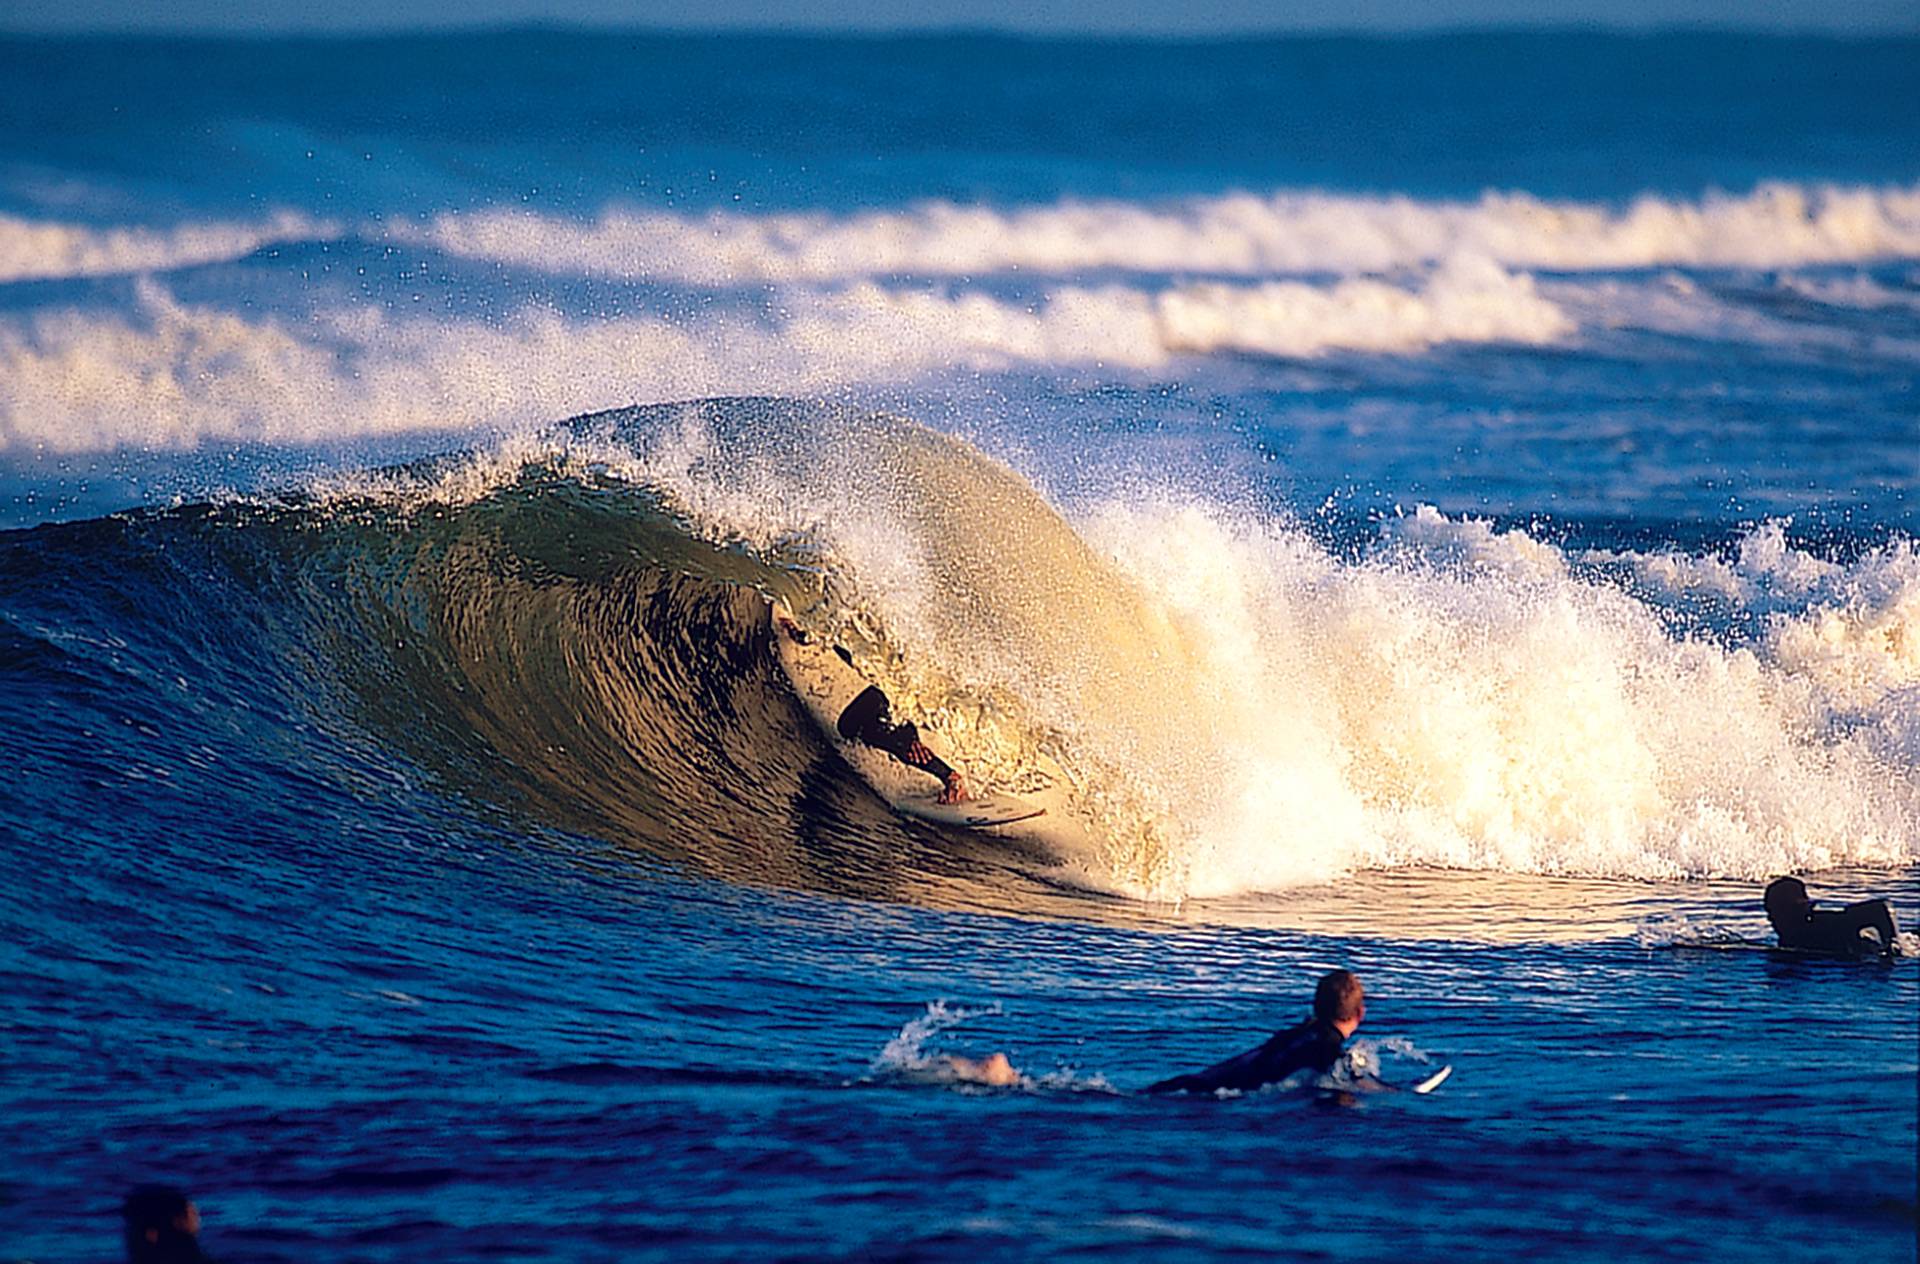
[766, 601, 1046, 830]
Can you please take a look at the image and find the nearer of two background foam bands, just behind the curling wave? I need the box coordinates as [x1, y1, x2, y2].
[0, 265, 1571, 451]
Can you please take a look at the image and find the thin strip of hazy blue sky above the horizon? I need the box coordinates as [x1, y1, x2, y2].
[0, 0, 1920, 35]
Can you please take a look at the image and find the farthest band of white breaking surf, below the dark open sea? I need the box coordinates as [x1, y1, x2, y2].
[0, 182, 1920, 286]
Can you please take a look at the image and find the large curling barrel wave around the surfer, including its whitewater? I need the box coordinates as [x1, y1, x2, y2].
[4, 400, 1920, 903]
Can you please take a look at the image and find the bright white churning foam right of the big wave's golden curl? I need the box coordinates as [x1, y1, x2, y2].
[1089, 505, 1920, 895]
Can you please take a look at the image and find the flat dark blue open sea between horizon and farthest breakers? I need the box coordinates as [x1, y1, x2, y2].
[0, 31, 1920, 210]
